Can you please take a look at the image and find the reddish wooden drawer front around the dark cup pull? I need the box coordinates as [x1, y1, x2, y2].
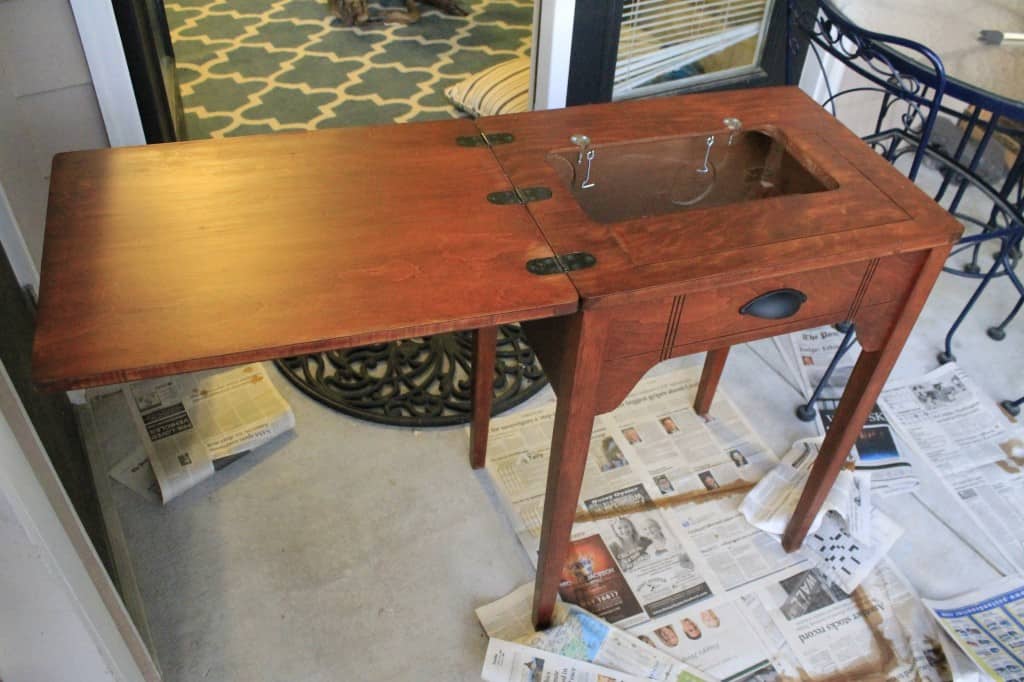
[672, 261, 874, 346]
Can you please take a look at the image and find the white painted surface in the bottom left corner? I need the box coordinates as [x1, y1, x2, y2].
[0, 365, 146, 682]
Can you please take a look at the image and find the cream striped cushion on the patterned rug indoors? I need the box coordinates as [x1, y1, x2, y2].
[444, 57, 529, 116]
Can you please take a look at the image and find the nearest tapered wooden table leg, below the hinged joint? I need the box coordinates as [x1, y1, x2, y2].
[534, 312, 608, 629]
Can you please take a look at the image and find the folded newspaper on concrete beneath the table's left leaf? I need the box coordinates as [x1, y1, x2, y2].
[110, 364, 295, 504]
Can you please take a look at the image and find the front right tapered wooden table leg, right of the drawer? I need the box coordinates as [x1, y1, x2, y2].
[782, 249, 949, 552]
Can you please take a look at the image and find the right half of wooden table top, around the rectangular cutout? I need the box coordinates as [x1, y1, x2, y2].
[478, 87, 962, 307]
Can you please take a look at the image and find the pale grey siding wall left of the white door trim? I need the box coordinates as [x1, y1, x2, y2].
[0, 0, 108, 268]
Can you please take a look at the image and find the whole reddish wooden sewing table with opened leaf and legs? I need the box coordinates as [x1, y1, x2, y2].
[33, 88, 962, 626]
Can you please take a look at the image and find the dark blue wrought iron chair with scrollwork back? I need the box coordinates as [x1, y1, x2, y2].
[786, 0, 1024, 421]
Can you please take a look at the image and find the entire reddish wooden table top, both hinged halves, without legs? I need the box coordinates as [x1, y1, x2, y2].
[33, 88, 962, 389]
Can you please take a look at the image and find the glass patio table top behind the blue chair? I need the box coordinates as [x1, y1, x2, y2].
[843, 0, 1024, 113]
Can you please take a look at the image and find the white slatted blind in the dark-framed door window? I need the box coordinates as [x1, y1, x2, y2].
[612, 0, 771, 99]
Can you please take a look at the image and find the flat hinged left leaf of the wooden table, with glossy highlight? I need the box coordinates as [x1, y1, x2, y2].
[33, 120, 579, 389]
